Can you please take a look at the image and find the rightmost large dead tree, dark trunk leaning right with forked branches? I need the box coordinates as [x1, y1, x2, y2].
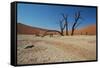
[71, 11, 81, 35]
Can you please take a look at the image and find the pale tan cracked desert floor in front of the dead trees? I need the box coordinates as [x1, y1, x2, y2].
[17, 35, 96, 64]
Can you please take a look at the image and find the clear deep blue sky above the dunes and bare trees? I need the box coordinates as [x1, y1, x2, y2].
[17, 3, 96, 30]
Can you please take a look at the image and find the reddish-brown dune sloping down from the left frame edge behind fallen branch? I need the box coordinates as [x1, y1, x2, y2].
[17, 23, 59, 35]
